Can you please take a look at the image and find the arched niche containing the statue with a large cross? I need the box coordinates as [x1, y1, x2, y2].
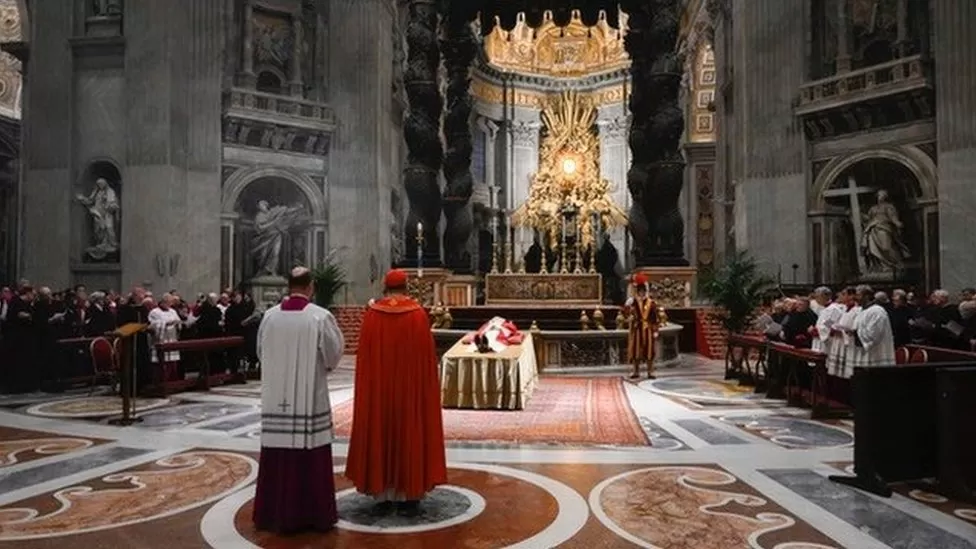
[811, 147, 939, 287]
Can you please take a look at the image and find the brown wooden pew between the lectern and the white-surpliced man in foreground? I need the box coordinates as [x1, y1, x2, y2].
[152, 336, 246, 396]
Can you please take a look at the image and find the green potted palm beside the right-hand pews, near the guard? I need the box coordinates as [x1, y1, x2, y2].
[701, 252, 775, 377]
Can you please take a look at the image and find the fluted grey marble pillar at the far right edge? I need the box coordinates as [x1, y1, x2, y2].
[932, 0, 976, 290]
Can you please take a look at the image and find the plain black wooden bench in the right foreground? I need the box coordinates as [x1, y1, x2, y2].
[830, 361, 976, 499]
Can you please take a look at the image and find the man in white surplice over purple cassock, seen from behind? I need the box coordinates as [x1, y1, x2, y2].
[254, 267, 345, 534]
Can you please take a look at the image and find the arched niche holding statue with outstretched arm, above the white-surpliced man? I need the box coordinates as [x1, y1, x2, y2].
[221, 167, 327, 286]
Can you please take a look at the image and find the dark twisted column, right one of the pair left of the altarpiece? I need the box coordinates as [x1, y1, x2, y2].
[441, 2, 478, 273]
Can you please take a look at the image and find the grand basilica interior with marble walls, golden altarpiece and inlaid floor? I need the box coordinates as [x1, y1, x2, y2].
[0, 0, 976, 549]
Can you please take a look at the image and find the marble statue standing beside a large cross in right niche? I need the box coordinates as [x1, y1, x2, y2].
[860, 190, 911, 273]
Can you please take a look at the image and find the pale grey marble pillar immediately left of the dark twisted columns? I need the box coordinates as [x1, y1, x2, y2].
[325, 0, 396, 303]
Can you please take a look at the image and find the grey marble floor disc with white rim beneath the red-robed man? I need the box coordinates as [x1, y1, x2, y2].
[336, 485, 486, 534]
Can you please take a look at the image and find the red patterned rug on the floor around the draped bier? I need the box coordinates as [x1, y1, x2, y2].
[333, 376, 650, 446]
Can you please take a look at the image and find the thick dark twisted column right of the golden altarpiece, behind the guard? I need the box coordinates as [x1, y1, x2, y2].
[623, 0, 688, 266]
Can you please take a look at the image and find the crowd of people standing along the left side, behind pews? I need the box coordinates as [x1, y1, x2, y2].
[0, 280, 260, 393]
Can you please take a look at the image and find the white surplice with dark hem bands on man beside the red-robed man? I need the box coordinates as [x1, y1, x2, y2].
[257, 303, 345, 449]
